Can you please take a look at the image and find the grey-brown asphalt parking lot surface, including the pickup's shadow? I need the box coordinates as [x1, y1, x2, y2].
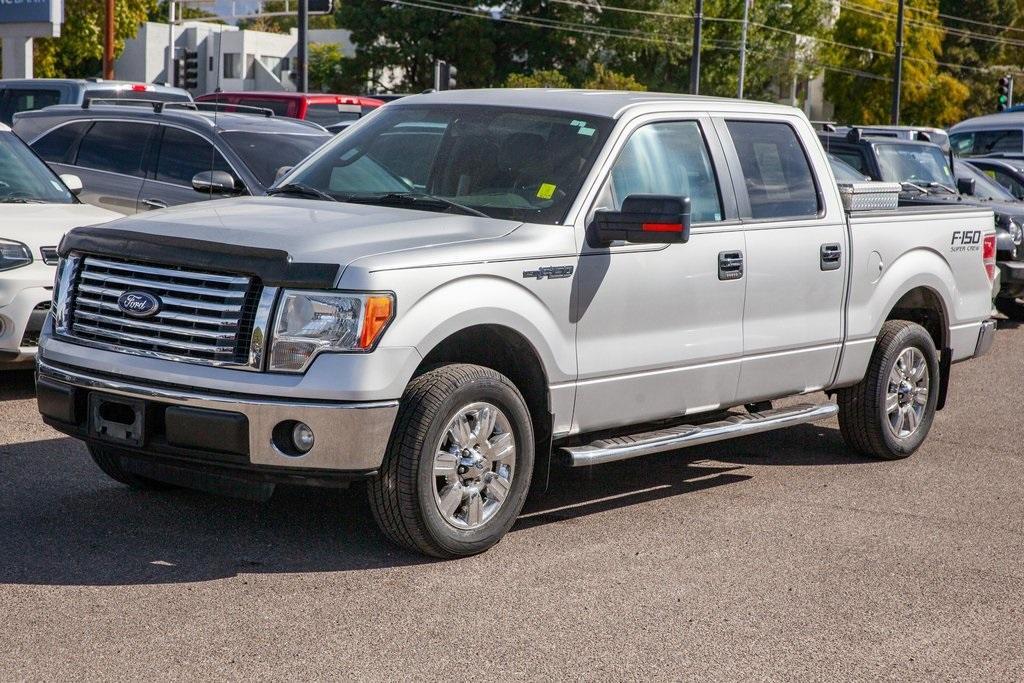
[0, 322, 1024, 681]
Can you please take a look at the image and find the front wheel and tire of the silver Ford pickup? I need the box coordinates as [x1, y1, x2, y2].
[368, 365, 534, 558]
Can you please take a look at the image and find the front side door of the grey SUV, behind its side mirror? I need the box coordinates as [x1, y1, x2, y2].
[138, 126, 239, 211]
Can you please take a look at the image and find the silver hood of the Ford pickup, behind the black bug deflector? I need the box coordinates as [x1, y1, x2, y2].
[80, 197, 519, 268]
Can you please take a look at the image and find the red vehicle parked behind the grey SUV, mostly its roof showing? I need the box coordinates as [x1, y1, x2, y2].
[196, 92, 384, 133]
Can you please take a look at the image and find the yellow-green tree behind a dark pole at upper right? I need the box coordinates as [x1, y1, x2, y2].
[825, 0, 969, 126]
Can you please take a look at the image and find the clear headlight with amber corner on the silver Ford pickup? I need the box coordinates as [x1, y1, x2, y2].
[269, 291, 394, 372]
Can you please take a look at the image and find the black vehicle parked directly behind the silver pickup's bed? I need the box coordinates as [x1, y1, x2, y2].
[819, 129, 1024, 319]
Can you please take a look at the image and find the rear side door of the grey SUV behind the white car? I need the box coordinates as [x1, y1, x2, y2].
[68, 121, 157, 214]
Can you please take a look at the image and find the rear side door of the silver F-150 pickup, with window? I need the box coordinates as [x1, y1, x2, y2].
[716, 116, 850, 402]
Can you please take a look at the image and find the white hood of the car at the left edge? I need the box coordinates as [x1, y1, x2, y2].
[0, 204, 121, 257]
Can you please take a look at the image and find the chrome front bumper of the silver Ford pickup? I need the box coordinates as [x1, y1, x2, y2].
[37, 360, 398, 471]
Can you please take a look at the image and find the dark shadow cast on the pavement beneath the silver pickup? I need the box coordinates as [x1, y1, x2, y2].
[0, 421, 853, 586]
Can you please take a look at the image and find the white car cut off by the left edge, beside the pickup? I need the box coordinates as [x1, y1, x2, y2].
[0, 124, 120, 369]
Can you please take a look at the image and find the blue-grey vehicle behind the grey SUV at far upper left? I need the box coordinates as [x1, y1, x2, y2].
[0, 78, 191, 126]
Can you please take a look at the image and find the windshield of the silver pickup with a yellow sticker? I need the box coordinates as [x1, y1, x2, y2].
[288, 104, 612, 224]
